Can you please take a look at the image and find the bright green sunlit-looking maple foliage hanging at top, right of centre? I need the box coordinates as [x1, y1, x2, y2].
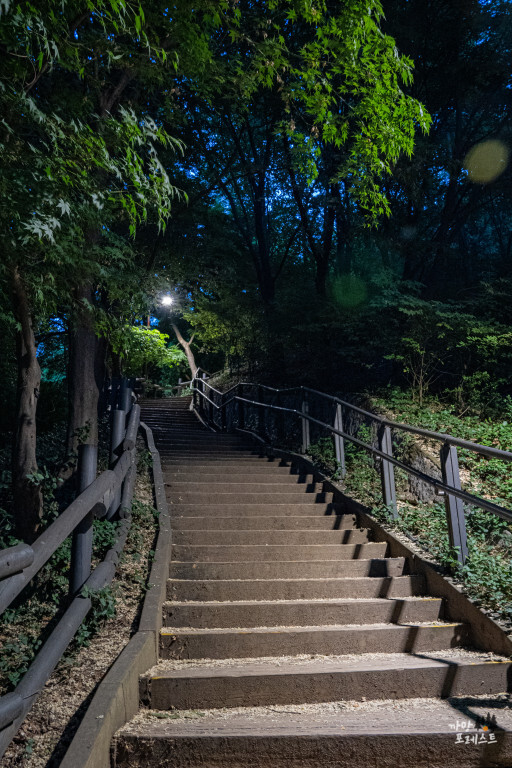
[224, 0, 430, 223]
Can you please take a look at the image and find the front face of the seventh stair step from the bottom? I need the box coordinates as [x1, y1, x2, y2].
[171, 542, 387, 563]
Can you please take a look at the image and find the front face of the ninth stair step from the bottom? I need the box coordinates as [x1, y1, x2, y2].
[171, 507, 357, 532]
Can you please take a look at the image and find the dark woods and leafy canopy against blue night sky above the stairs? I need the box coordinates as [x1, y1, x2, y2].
[0, 0, 512, 534]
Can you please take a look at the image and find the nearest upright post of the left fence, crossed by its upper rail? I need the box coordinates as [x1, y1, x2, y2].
[69, 444, 98, 595]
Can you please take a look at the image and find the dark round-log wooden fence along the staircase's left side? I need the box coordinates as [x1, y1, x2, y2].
[0, 380, 140, 759]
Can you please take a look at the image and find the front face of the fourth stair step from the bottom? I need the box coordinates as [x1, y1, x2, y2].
[163, 597, 443, 629]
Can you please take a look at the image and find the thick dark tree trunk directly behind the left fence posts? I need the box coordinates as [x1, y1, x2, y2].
[68, 284, 106, 452]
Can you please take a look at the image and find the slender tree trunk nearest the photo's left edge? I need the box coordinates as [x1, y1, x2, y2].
[12, 267, 43, 543]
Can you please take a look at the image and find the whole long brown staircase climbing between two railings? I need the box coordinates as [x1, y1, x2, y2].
[114, 398, 512, 768]
